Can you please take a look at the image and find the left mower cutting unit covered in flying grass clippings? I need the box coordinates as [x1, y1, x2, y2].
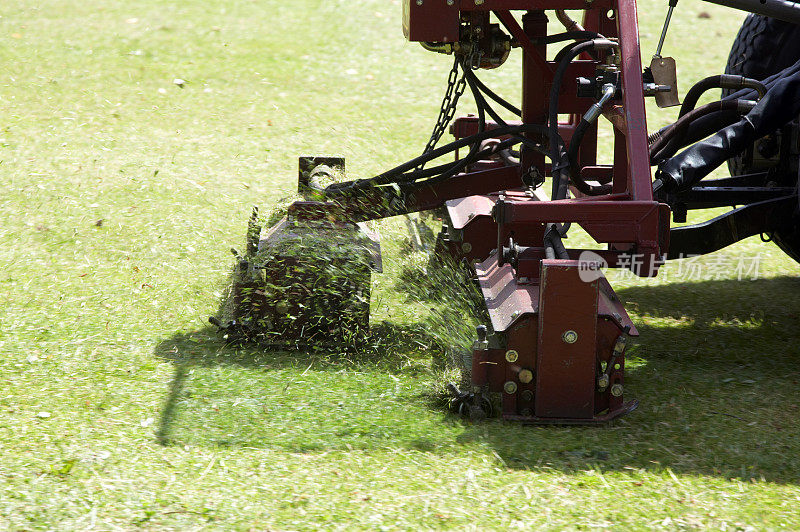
[212, 208, 376, 345]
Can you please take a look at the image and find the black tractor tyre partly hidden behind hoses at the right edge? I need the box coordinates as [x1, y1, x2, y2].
[722, 14, 800, 262]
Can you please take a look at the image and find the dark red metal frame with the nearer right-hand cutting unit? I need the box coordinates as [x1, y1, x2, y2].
[289, 0, 669, 424]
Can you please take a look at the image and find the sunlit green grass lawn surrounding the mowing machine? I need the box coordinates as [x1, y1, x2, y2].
[0, 0, 800, 530]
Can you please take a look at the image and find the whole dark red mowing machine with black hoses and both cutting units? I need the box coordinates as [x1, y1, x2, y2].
[212, 0, 800, 424]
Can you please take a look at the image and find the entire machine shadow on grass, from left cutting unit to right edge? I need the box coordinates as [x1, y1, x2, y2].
[156, 278, 800, 483]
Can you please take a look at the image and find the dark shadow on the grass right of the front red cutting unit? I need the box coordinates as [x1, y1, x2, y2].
[459, 277, 800, 484]
